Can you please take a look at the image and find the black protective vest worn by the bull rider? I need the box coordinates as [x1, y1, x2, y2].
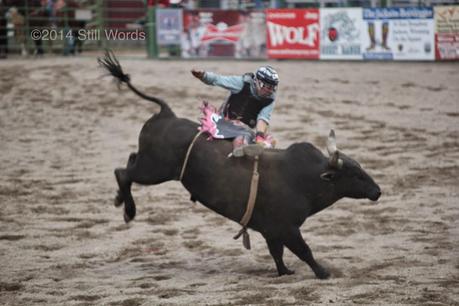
[223, 74, 274, 128]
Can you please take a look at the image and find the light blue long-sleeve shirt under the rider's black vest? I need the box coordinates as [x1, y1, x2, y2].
[202, 71, 275, 124]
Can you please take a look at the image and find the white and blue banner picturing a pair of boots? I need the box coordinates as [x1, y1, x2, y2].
[362, 7, 435, 60]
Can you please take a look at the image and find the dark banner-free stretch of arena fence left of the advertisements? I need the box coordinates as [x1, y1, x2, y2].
[0, 0, 146, 55]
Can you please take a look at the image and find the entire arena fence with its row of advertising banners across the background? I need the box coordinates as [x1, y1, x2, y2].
[0, 0, 459, 61]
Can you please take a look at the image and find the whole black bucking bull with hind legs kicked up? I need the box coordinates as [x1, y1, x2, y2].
[99, 54, 381, 279]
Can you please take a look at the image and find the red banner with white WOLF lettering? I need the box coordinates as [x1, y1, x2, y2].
[266, 9, 320, 59]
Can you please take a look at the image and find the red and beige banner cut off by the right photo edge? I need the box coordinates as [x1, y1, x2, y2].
[435, 6, 459, 60]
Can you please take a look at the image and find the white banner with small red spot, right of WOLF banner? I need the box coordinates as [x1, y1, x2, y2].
[320, 8, 366, 60]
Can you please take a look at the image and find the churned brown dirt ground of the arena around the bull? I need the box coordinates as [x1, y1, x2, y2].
[0, 58, 459, 306]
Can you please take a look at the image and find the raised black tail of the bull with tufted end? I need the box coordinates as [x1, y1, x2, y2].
[97, 50, 175, 116]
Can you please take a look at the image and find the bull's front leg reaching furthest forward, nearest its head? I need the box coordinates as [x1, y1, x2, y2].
[284, 228, 330, 279]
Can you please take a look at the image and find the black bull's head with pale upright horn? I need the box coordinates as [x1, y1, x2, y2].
[320, 130, 381, 201]
